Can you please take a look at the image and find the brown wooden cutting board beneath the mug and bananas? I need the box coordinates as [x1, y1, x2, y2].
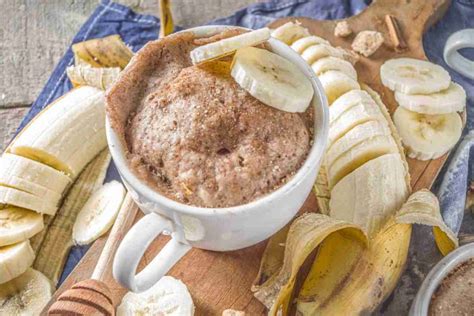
[42, 0, 450, 315]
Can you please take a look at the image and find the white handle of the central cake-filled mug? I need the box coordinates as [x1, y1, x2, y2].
[112, 213, 191, 292]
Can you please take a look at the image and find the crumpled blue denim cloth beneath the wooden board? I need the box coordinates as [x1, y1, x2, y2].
[14, 0, 474, 315]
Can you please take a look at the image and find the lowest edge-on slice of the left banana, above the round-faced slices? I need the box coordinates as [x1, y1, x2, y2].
[0, 186, 58, 215]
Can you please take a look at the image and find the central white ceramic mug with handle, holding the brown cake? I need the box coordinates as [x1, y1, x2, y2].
[106, 26, 329, 292]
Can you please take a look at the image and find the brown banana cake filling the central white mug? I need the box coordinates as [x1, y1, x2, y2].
[107, 30, 313, 207]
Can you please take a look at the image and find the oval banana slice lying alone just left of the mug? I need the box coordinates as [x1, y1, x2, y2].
[72, 181, 126, 245]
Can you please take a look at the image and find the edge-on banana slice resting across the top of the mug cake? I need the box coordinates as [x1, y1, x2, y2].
[190, 27, 270, 65]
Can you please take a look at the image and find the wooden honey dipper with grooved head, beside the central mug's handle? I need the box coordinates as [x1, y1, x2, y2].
[48, 193, 138, 316]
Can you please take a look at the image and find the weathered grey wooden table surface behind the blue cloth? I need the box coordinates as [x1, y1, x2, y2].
[0, 0, 262, 152]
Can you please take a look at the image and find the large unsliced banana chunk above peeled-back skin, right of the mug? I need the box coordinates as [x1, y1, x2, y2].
[329, 153, 409, 237]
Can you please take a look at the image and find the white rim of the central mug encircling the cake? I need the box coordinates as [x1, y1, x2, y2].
[106, 25, 329, 216]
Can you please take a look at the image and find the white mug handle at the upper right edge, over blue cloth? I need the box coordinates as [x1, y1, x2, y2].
[443, 29, 474, 79]
